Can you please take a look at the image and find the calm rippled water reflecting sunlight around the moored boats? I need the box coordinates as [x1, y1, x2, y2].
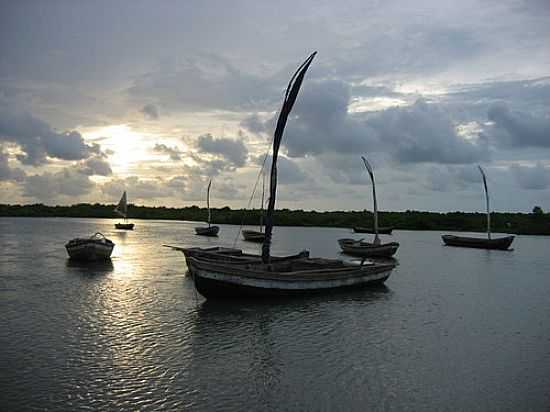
[0, 218, 550, 411]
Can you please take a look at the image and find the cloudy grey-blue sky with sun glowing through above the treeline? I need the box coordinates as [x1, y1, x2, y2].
[0, 0, 550, 212]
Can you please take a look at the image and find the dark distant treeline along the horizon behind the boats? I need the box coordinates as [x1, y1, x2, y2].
[0, 203, 550, 235]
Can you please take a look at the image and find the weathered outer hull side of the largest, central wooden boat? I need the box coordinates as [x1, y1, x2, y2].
[187, 258, 394, 299]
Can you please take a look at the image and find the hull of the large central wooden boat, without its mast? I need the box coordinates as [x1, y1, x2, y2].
[186, 257, 395, 299]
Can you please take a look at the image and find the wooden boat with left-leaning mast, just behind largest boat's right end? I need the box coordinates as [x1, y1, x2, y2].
[338, 156, 399, 257]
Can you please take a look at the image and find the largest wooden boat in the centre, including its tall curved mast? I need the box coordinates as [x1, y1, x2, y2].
[177, 53, 395, 299]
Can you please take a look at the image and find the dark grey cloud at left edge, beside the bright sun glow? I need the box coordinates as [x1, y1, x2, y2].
[0, 106, 101, 165]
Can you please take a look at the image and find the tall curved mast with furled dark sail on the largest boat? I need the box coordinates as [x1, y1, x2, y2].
[262, 52, 317, 263]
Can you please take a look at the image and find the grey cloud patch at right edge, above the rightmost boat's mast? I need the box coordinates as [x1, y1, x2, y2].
[488, 103, 550, 147]
